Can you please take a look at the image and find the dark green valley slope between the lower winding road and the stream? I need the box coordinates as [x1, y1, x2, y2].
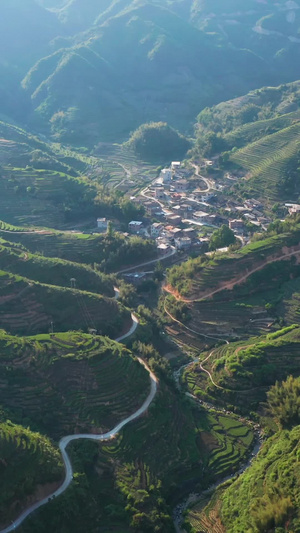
[19, 380, 253, 533]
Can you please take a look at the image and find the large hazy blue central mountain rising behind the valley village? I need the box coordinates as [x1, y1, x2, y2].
[23, 2, 275, 143]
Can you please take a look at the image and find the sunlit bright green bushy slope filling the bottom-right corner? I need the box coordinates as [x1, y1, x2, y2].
[188, 426, 300, 533]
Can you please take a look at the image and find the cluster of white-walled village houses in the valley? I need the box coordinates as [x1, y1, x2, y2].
[97, 160, 300, 270]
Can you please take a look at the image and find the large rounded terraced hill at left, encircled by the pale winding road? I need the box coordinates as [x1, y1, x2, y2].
[0, 332, 150, 440]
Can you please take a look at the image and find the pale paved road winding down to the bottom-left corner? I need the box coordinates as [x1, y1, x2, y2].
[0, 314, 158, 533]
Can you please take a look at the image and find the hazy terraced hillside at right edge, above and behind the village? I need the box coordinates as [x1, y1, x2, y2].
[194, 82, 300, 202]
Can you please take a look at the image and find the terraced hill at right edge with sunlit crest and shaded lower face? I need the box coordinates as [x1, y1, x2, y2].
[183, 325, 300, 409]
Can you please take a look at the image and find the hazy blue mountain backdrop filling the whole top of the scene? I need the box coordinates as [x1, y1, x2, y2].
[0, 0, 300, 144]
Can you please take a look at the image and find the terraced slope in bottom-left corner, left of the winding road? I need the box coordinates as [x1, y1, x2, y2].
[0, 417, 63, 527]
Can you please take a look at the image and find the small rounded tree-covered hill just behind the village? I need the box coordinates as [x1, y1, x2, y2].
[128, 122, 190, 161]
